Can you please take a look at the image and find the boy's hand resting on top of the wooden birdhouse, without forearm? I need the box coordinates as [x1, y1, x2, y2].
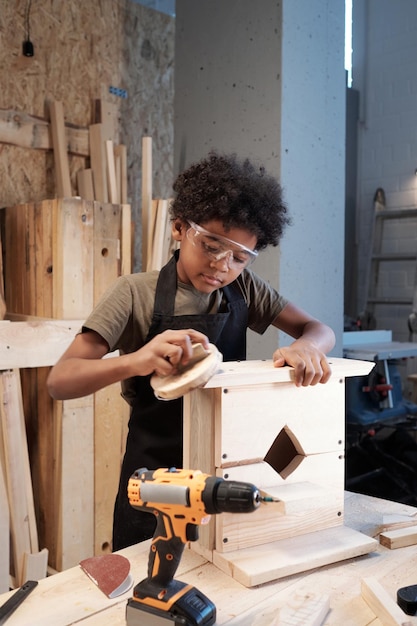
[272, 339, 332, 387]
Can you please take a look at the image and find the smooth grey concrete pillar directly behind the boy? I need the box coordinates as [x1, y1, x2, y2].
[174, 0, 345, 358]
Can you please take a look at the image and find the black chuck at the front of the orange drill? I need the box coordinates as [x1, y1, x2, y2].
[201, 476, 261, 515]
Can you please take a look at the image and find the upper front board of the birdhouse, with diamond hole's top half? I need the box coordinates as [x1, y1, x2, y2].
[215, 376, 345, 464]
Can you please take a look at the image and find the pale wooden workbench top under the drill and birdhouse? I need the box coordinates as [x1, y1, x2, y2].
[0, 493, 417, 626]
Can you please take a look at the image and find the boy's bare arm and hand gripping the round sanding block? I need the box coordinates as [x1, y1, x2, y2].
[47, 329, 209, 400]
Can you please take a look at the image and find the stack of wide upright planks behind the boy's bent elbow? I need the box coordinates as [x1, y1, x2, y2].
[3, 198, 131, 570]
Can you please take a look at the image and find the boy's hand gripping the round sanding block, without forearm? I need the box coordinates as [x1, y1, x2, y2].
[136, 328, 209, 376]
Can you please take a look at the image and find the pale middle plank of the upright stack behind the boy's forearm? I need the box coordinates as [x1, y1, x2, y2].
[51, 198, 94, 570]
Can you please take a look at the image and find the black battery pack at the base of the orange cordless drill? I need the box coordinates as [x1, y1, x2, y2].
[126, 581, 216, 626]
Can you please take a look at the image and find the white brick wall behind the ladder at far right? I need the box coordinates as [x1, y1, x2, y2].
[352, 0, 417, 341]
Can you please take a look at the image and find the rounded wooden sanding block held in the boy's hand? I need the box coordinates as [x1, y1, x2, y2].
[151, 343, 223, 400]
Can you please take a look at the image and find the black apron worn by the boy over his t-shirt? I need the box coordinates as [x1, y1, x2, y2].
[113, 252, 248, 550]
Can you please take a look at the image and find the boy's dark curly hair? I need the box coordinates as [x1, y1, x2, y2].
[170, 151, 291, 250]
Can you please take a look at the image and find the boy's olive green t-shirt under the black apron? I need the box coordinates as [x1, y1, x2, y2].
[82, 269, 287, 400]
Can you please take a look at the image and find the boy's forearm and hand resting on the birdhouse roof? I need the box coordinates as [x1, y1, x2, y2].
[273, 302, 335, 387]
